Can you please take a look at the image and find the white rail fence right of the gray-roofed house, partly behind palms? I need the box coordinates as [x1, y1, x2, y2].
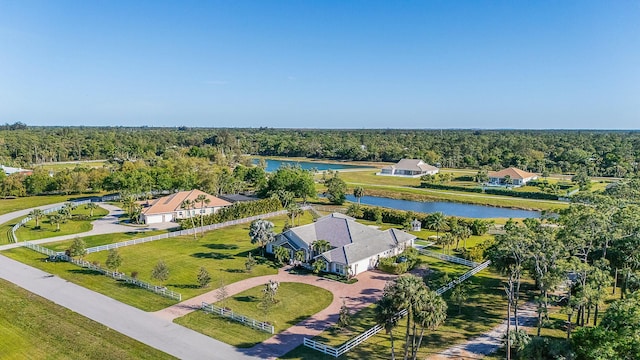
[303, 258, 491, 357]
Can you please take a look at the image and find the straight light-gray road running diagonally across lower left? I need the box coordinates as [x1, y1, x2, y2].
[0, 255, 254, 360]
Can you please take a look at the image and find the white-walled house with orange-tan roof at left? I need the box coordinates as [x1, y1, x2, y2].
[142, 190, 231, 224]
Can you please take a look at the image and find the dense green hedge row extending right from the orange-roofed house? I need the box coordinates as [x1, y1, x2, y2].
[180, 198, 282, 229]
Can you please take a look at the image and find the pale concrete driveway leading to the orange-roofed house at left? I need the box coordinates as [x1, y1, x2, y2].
[0, 203, 178, 250]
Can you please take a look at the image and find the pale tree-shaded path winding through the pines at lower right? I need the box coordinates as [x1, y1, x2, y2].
[427, 302, 538, 360]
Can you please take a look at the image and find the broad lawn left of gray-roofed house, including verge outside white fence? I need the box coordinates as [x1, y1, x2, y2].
[5, 213, 312, 311]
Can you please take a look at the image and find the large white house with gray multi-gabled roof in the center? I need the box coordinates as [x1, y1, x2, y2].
[267, 213, 416, 275]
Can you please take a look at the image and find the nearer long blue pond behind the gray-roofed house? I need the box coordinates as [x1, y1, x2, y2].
[347, 195, 540, 218]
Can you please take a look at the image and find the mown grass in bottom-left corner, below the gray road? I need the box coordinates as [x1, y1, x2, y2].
[0, 279, 173, 360]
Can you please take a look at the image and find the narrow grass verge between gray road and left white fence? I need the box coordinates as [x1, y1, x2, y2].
[2, 247, 176, 311]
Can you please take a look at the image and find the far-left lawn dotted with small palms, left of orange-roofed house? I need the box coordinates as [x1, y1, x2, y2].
[16, 205, 109, 241]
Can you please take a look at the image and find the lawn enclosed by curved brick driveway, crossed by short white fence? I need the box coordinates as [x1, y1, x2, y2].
[175, 283, 333, 348]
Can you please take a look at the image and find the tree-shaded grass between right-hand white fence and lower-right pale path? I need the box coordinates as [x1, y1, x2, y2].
[282, 258, 506, 359]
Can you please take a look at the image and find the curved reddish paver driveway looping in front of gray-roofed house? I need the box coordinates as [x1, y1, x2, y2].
[154, 269, 395, 359]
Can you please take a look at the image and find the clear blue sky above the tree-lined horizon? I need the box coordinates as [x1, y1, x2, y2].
[0, 0, 640, 129]
